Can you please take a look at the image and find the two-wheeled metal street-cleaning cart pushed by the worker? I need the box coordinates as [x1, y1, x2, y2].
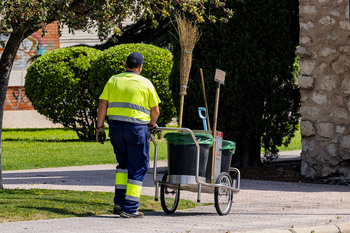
[150, 127, 240, 215]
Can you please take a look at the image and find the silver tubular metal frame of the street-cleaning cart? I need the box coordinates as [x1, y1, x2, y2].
[150, 127, 240, 215]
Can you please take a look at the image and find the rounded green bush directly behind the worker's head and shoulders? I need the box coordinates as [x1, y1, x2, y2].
[90, 44, 175, 126]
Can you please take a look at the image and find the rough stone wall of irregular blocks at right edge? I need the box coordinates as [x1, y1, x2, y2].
[298, 0, 350, 178]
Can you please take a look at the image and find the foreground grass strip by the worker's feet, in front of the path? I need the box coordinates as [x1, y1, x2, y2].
[0, 189, 198, 223]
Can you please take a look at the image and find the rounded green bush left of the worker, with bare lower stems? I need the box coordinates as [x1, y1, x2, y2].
[25, 47, 101, 139]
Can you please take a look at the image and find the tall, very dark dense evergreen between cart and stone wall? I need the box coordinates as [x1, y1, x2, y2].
[171, 0, 300, 166]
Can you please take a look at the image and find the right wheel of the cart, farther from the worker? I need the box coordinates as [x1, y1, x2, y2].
[214, 172, 233, 215]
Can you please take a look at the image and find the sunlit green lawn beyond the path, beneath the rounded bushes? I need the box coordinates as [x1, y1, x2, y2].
[2, 128, 301, 171]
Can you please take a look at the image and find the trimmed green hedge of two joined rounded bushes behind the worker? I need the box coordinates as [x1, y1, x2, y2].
[25, 44, 175, 140]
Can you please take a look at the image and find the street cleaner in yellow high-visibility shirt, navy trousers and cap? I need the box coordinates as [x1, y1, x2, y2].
[96, 52, 160, 218]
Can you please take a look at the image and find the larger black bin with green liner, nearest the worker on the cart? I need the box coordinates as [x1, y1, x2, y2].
[164, 132, 213, 184]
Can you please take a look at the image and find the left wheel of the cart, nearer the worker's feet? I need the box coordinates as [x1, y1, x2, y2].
[160, 172, 180, 214]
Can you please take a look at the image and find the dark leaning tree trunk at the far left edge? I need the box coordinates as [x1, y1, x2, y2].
[0, 28, 33, 189]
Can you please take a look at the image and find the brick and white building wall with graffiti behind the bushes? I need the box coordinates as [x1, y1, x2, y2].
[0, 23, 106, 128]
